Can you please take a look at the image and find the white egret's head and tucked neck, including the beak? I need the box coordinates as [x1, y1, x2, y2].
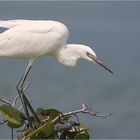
[57, 44, 113, 73]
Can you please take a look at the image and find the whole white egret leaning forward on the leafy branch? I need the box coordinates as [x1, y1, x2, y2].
[0, 20, 113, 128]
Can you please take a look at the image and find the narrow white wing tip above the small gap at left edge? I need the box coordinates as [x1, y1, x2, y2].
[0, 19, 32, 28]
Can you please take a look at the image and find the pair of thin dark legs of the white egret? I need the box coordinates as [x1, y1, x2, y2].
[17, 60, 40, 129]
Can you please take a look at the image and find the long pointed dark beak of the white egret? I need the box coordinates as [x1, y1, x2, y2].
[87, 53, 113, 74]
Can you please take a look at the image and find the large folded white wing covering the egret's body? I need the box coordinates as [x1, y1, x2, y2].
[0, 21, 68, 59]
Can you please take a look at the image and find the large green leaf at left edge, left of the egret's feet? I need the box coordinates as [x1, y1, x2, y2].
[0, 104, 25, 128]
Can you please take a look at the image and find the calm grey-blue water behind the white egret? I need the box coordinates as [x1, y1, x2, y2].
[0, 2, 140, 138]
